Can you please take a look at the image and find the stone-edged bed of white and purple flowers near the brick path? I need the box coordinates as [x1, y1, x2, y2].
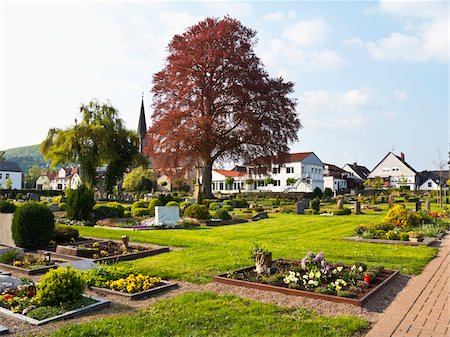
[214, 253, 398, 306]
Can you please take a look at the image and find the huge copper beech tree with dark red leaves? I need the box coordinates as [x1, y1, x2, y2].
[146, 17, 301, 198]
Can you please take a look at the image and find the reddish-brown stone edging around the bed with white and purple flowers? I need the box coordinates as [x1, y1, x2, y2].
[213, 259, 399, 307]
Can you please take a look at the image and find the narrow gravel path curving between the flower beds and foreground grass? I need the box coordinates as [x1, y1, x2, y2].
[0, 275, 409, 337]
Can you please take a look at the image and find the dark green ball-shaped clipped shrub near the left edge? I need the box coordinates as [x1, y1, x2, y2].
[12, 202, 55, 248]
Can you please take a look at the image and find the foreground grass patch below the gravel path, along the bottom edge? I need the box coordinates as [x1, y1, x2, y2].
[45, 292, 368, 337]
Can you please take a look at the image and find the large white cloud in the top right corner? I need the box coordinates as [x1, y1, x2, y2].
[366, 1, 449, 62]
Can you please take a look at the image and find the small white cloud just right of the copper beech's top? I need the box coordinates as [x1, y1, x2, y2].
[282, 18, 330, 47]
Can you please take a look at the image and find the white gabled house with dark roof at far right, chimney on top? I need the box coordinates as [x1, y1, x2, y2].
[367, 152, 419, 190]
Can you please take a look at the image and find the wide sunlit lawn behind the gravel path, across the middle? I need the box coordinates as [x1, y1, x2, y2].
[78, 213, 437, 283]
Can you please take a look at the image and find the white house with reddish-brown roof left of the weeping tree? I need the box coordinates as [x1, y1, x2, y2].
[36, 167, 81, 191]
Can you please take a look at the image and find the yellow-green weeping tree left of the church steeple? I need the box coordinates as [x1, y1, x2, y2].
[40, 101, 142, 189]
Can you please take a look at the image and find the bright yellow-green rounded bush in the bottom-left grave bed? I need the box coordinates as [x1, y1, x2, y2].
[36, 267, 86, 306]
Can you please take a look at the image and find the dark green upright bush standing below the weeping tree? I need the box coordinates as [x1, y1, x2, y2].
[66, 184, 95, 220]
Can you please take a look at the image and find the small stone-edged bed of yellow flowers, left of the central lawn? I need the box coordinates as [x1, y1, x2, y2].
[85, 265, 177, 300]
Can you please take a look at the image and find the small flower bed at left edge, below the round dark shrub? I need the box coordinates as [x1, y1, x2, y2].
[0, 251, 64, 275]
